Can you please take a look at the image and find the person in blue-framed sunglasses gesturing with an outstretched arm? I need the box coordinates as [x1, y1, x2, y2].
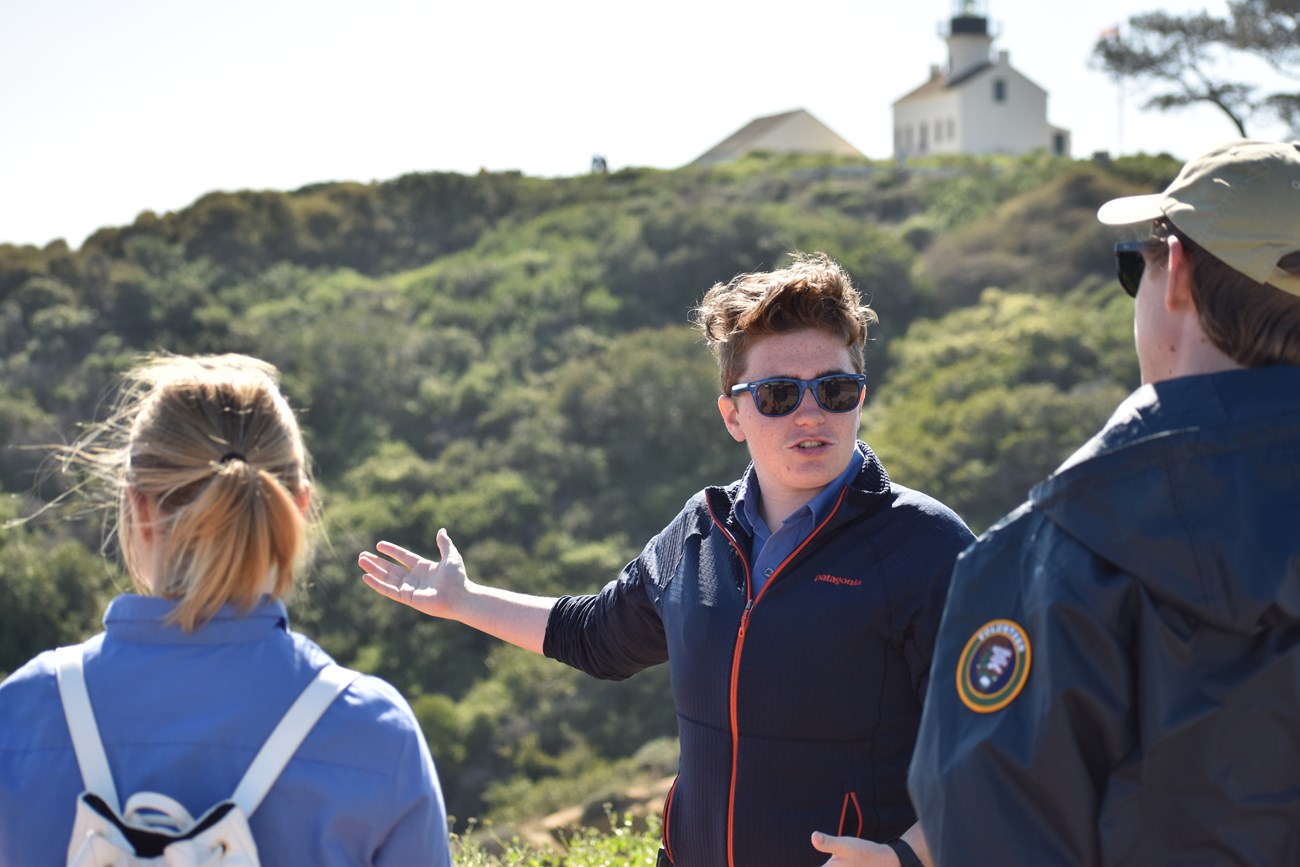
[359, 255, 974, 867]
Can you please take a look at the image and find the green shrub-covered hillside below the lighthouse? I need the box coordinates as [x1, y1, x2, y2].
[0, 149, 1178, 828]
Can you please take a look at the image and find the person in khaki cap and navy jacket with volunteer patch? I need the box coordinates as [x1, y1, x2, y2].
[910, 140, 1300, 866]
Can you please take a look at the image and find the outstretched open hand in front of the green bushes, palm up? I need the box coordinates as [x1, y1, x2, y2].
[356, 529, 468, 617]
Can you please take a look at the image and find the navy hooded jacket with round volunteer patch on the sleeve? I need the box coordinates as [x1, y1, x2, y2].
[911, 365, 1300, 867]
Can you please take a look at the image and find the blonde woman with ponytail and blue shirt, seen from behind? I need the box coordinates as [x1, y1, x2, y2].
[0, 355, 450, 867]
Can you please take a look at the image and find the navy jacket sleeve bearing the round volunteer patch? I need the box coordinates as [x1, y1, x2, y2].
[909, 510, 1136, 867]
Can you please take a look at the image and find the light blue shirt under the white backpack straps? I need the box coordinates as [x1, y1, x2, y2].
[0, 595, 451, 867]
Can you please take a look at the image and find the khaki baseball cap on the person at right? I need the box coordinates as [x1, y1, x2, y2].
[1097, 139, 1300, 295]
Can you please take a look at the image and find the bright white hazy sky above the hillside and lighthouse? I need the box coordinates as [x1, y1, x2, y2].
[0, 0, 1286, 247]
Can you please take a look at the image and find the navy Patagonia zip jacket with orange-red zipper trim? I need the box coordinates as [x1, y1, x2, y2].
[545, 443, 972, 867]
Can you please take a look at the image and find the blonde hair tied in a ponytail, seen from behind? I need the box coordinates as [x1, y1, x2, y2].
[74, 355, 312, 632]
